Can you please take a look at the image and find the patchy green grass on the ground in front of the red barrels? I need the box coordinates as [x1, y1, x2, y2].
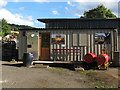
[75, 70, 117, 90]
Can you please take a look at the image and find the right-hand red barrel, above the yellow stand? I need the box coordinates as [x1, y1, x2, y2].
[96, 54, 109, 65]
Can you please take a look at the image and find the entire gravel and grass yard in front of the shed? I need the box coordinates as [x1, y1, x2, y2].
[2, 62, 118, 88]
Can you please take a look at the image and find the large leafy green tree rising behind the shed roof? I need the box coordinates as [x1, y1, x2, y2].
[81, 4, 116, 18]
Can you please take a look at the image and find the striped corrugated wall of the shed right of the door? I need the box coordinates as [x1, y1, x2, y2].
[50, 29, 114, 61]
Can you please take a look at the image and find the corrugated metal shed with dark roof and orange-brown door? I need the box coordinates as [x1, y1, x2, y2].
[19, 18, 120, 61]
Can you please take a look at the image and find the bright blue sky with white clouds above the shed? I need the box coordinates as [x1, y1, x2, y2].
[0, 0, 119, 28]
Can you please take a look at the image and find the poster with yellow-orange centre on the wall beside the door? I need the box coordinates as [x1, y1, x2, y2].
[51, 34, 65, 44]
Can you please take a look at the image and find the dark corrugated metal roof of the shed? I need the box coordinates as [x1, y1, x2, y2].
[20, 18, 120, 34]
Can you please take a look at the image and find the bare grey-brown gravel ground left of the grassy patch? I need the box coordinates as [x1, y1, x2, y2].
[2, 60, 90, 88]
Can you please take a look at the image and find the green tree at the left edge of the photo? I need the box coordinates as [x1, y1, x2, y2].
[2, 19, 11, 37]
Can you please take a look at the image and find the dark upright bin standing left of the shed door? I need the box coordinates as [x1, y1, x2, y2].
[23, 53, 33, 66]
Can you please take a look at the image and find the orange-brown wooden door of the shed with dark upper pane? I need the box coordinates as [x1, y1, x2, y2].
[39, 33, 50, 60]
